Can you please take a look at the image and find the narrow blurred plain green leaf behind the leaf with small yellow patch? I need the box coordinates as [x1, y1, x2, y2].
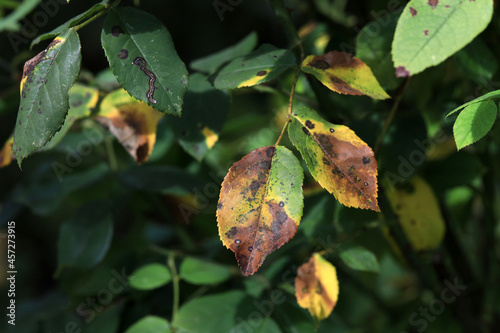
[189, 31, 257, 74]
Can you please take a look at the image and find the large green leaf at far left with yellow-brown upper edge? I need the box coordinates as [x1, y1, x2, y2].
[12, 29, 81, 166]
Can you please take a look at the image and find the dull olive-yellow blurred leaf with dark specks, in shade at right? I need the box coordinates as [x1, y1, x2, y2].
[385, 176, 446, 251]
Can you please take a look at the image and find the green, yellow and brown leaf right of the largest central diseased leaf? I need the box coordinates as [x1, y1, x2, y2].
[288, 107, 379, 211]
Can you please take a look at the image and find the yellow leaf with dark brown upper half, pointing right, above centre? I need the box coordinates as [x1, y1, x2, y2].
[302, 51, 390, 99]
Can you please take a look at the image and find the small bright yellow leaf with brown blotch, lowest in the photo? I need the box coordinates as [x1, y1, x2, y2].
[295, 253, 339, 322]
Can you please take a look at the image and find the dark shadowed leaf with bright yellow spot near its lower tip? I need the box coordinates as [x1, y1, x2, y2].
[170, 73, 229, 161]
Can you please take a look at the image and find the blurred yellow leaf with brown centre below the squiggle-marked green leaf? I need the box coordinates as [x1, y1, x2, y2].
[96, 89, 163, 164]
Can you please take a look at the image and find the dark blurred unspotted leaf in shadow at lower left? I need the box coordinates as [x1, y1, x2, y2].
[57, 201, 113, 269]
